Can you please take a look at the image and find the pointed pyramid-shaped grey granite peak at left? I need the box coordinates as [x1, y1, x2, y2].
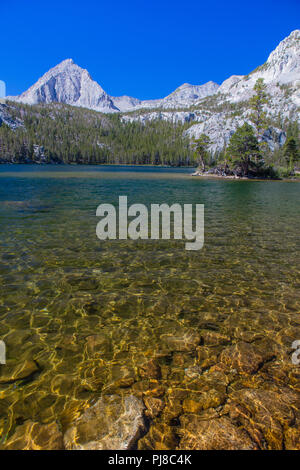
[15, 59, 118, 112]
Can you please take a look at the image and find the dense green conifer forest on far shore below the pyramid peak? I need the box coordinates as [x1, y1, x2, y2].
[0, 103, 194, 166]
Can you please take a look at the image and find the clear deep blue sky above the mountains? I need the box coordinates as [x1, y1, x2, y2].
[0, 0, 300, 99]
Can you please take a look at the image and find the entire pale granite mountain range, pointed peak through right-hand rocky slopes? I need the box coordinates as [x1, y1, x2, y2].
[4, 30, 300, 151]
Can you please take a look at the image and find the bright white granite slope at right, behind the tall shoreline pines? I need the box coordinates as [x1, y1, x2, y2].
[123, 30, 300, 152]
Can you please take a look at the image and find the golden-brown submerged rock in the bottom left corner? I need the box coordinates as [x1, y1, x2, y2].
[2, 421, 63, 450]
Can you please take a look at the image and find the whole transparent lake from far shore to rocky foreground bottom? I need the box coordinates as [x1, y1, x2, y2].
[0, 165, 300, 450]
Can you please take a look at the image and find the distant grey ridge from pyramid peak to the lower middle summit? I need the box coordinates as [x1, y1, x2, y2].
[7, 59, 219, 113]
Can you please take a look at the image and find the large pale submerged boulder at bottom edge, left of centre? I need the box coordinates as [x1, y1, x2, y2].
[64, 395, 145, 450]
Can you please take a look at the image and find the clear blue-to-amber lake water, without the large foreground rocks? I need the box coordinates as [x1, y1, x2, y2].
[0, 165, 300, 448]
